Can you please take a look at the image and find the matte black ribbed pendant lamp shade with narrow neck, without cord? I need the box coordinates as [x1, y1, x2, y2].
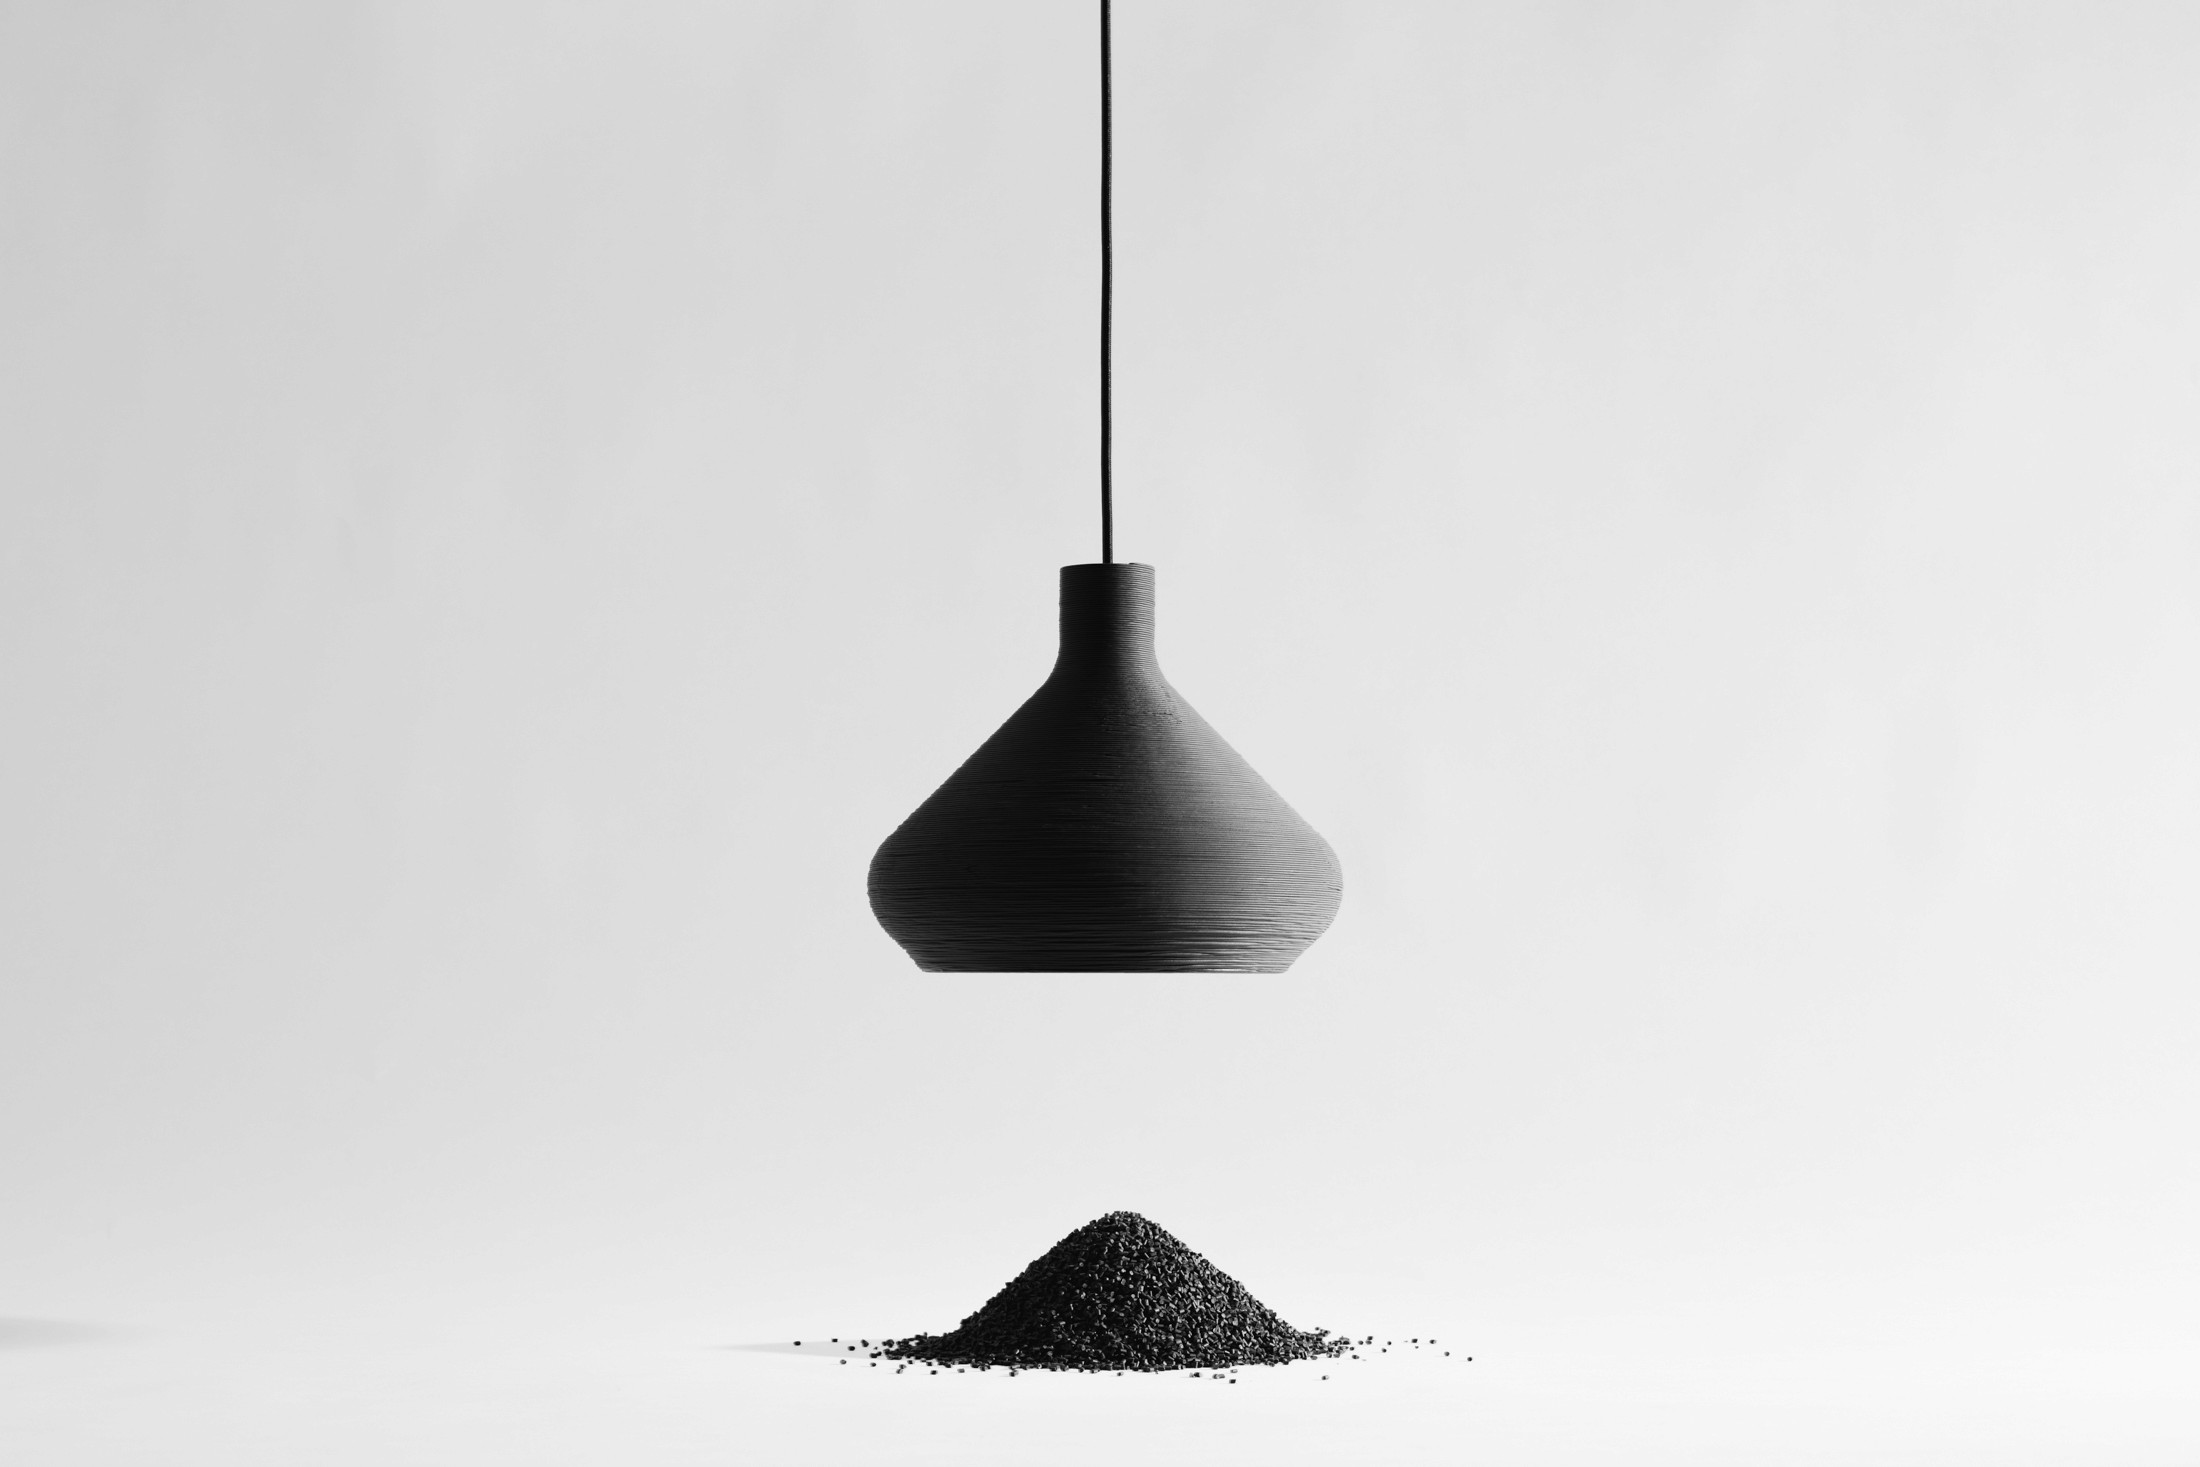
[871, 563, 1342, 972]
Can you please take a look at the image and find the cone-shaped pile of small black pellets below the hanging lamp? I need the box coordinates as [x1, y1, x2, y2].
[880, 1212, 1351, 1370]
